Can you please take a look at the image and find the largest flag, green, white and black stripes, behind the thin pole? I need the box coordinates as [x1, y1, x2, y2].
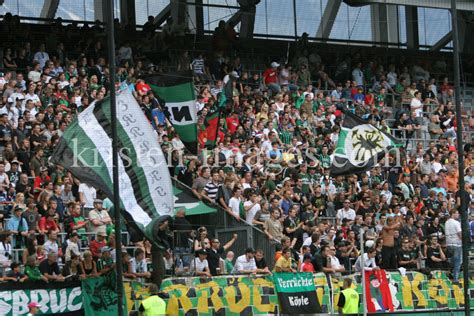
[51, 90, 174, 241]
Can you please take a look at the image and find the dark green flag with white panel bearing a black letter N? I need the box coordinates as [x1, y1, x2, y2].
[143, 72, 198, 154]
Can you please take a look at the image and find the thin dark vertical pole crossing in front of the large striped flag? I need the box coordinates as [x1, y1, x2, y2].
[104, 0, 123, 316]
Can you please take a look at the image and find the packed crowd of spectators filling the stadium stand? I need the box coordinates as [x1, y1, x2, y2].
[0, 12, 474, 282]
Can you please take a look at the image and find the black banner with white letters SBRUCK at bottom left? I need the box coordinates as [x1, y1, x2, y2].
[0, 281, 84, 316]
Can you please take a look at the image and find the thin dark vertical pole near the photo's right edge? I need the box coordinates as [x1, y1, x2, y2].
[451, 0, 470, 316]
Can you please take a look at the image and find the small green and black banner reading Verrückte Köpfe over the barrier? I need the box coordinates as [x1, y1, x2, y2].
[273, 272, 321, 314]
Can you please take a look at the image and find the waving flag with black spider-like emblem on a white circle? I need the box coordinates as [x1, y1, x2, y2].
[331, 112, 400, 176]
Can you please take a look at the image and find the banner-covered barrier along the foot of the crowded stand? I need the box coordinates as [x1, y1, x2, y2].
[0, 271, 474, 316]
